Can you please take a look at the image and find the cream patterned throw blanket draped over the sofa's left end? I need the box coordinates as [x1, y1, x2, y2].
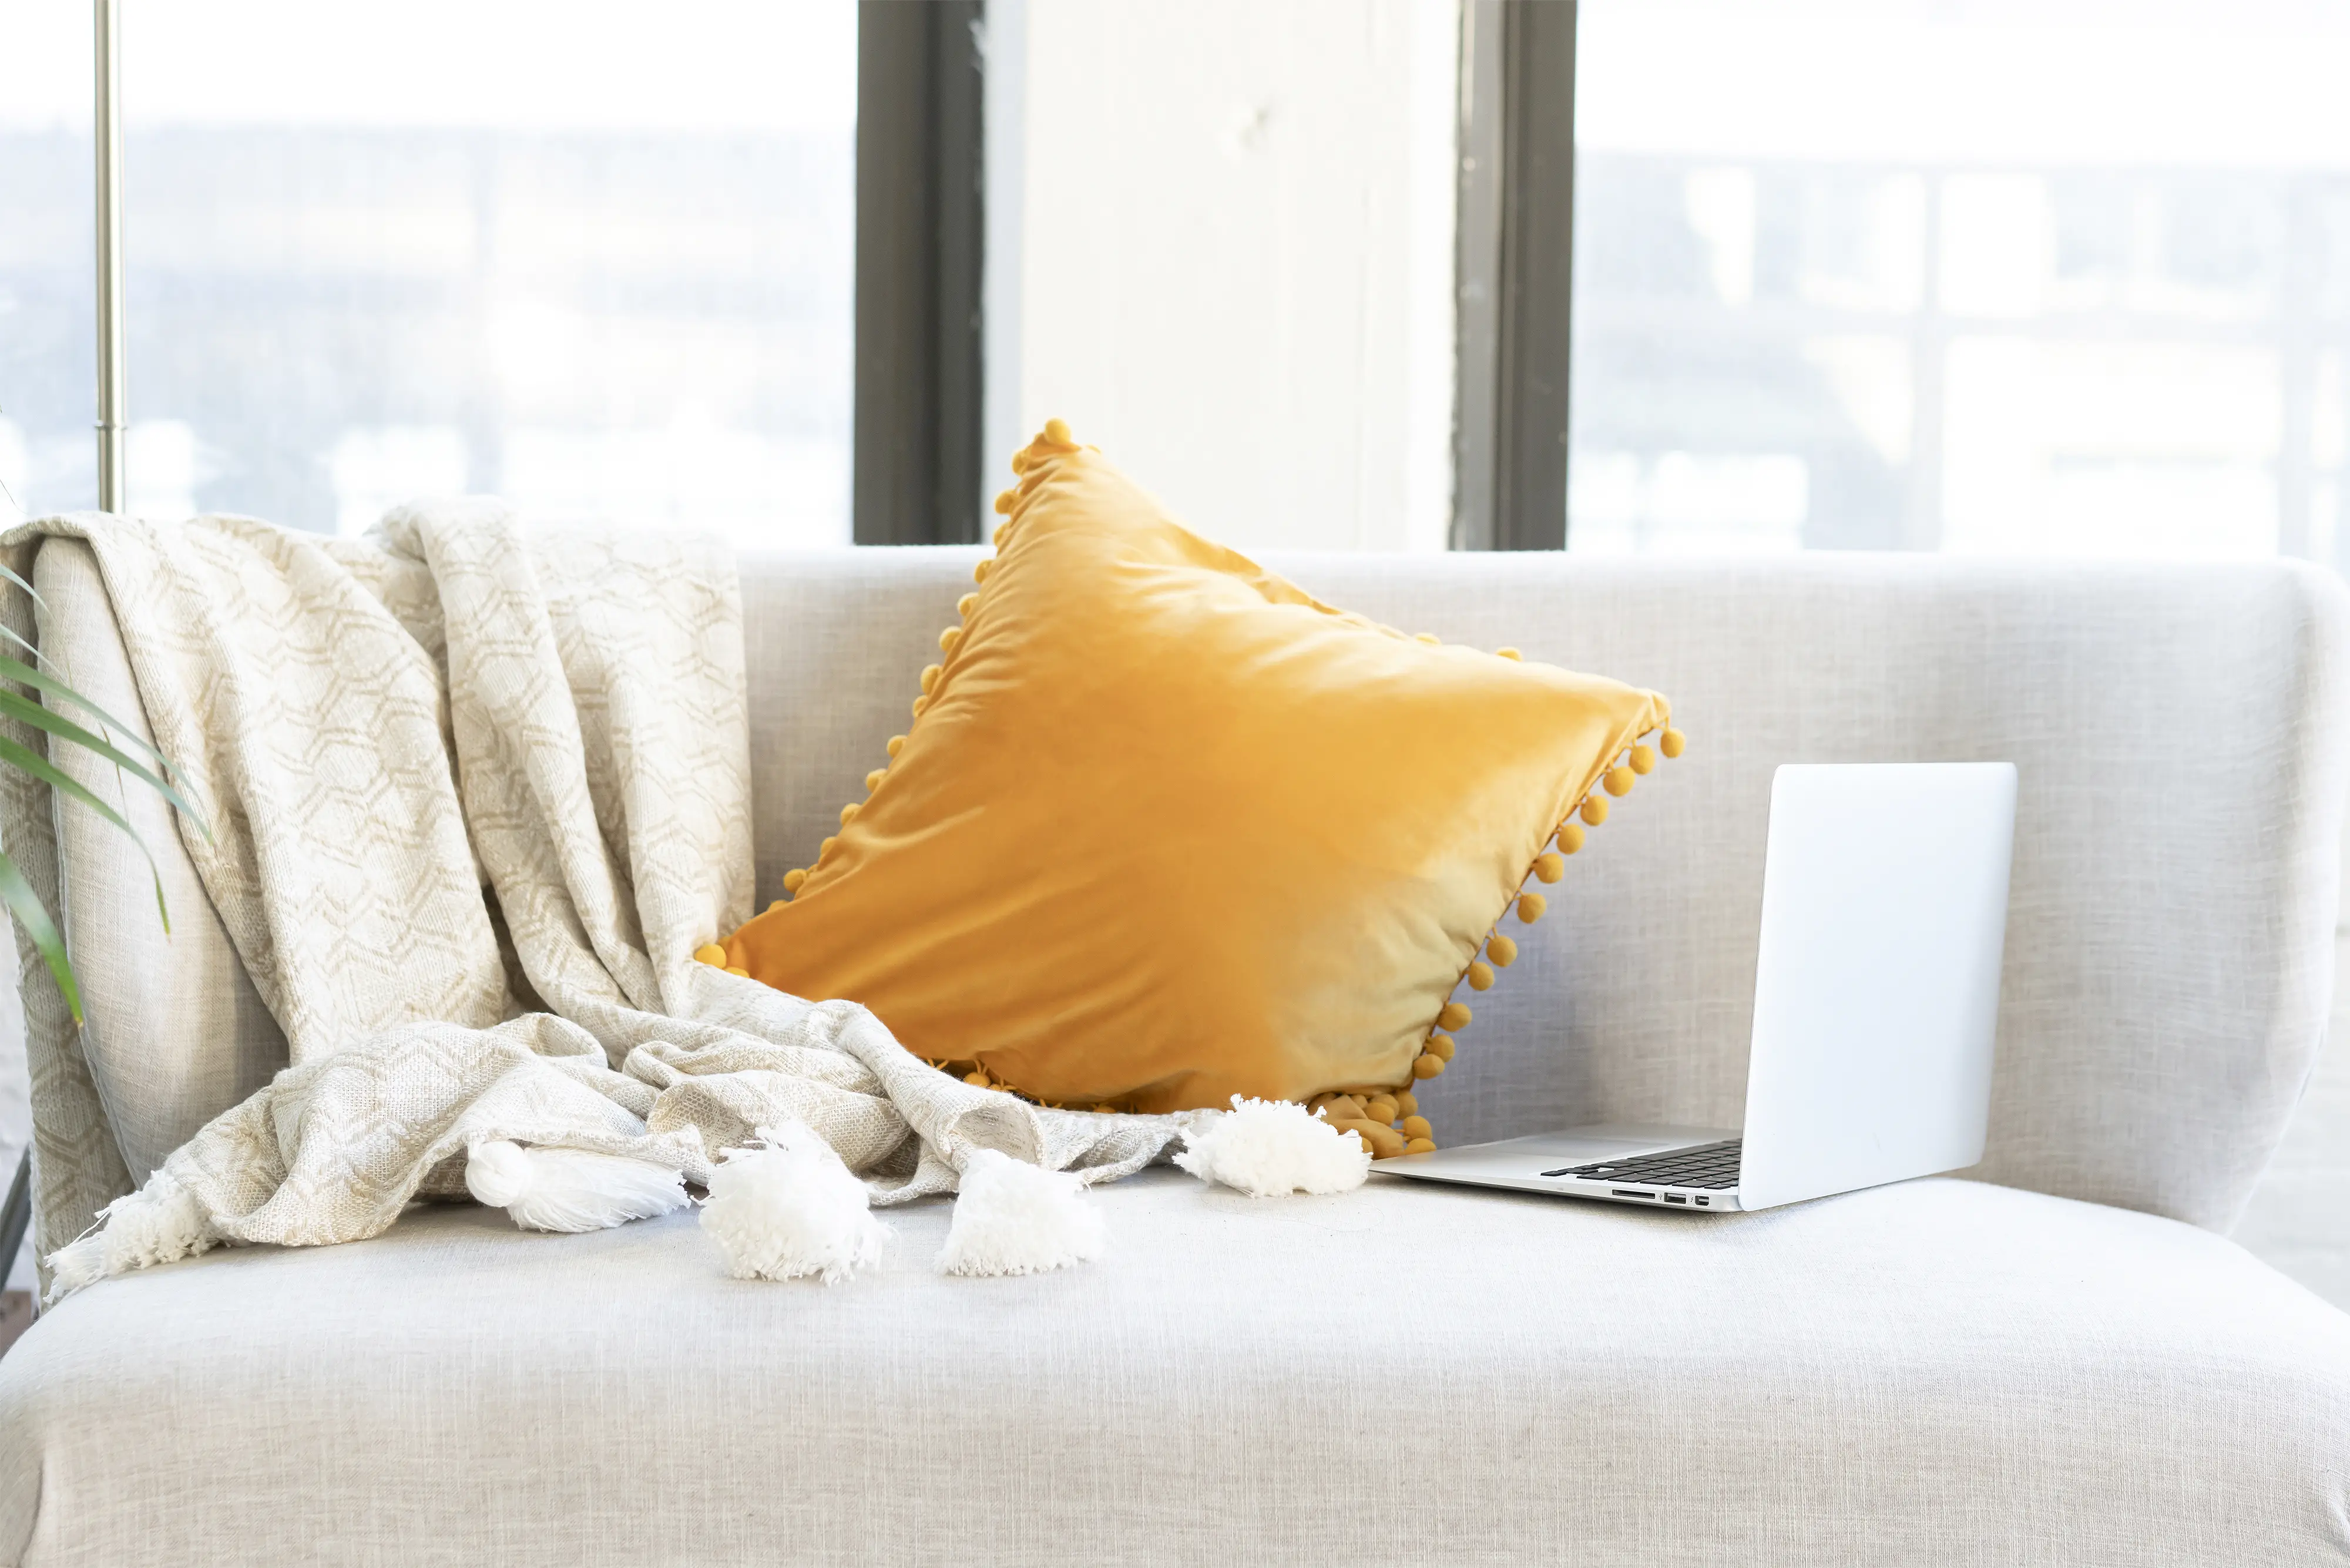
[0, 501, 1177, 1288]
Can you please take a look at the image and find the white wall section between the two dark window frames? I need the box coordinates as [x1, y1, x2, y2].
[987, 0, 1459, 550]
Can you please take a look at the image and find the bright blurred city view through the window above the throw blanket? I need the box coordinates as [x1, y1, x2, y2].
[0, 0, 858, 545]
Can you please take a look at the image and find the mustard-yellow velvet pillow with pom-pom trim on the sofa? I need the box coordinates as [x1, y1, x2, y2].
[700, 421, 1680, 1154]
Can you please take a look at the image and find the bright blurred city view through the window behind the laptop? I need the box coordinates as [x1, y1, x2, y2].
[1567, 0, 2350, 564]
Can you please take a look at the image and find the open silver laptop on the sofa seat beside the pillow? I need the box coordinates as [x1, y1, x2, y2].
[1372, 761, 2016, 1211]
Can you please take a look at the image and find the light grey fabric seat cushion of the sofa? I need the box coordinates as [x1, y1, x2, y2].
[0, 1171, 2350, 1566]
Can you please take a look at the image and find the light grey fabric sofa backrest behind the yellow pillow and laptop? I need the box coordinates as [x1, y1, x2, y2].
[743, 548, 2350, 1227]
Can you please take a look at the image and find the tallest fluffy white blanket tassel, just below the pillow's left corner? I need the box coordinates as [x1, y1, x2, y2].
[703, 1122, 888, 1286]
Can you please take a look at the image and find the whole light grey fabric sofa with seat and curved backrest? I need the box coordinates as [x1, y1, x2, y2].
[0, 543, 2350, 1566]
